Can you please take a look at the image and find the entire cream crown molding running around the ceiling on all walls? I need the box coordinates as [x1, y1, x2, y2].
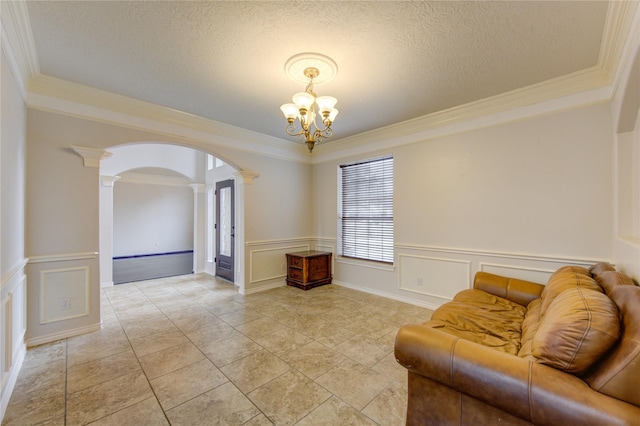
[7, 1, 640, 164]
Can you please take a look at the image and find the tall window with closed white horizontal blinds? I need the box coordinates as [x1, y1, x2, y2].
[340, 157, 393, 263]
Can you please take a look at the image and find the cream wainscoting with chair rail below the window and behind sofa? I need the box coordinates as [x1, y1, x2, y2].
[333, 244, 609, 309]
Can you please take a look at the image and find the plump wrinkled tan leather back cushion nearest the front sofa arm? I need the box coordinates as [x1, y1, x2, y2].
[531, 287, 620, 374]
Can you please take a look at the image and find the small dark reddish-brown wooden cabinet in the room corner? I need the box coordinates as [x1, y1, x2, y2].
[286, 250, 331, 290]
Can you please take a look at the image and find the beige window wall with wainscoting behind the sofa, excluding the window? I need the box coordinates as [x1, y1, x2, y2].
[313, 104, 614, 307]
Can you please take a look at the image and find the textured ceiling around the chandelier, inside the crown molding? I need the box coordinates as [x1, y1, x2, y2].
[27, 1, 608, 139]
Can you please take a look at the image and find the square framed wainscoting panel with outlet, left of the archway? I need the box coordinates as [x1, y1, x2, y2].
[40, 266, 90, 324]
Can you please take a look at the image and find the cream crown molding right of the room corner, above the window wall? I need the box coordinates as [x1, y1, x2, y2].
[312, 1, 640, 164]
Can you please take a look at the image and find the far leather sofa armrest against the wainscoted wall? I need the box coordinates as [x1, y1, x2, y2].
[473, 272, 544, 306]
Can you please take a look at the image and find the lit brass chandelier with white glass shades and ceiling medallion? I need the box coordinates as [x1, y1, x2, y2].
[280, 54, 338, 152]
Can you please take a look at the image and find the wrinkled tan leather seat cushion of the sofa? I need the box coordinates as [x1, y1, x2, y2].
[424, 289, 527, 355]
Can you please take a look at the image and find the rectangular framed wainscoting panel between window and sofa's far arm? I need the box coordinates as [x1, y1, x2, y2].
[398, 255, 471, 300]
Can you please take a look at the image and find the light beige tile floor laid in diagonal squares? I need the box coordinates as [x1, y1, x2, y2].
[2, 275, 431, 426]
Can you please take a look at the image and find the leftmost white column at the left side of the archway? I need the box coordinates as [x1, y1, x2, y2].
[98, 176, 120, 287]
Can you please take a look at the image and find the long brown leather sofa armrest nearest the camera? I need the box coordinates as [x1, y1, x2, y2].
[395, 324, 640, 425]
